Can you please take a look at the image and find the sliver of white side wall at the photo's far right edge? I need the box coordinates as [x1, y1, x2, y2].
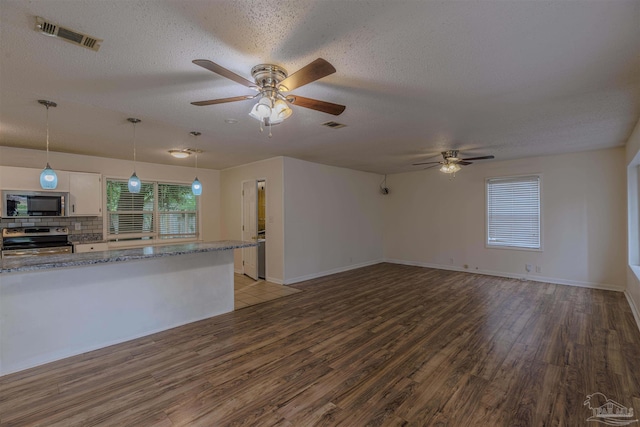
[626, 120, 640, 327]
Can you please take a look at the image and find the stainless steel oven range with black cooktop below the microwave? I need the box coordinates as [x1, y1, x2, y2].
[2, 227, 73, 258]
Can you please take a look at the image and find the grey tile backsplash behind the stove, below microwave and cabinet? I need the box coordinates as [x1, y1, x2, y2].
[0, 216, 103, 241]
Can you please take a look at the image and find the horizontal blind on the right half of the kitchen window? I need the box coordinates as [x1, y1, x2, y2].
[158, 184, 198, 239]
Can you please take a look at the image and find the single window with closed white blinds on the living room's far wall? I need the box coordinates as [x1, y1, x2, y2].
[487, 175, 542, 249]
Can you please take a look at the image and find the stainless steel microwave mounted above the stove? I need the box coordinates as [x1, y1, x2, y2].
[2, 190, 69, 218]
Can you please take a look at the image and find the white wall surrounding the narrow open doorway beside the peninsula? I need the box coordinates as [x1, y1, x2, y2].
[220, 157, 284, 283]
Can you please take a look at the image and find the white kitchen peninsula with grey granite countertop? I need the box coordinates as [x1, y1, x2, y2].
[0, 241, 256, 375]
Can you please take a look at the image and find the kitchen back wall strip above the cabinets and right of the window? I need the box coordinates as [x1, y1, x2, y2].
[0, 147, 220, 241]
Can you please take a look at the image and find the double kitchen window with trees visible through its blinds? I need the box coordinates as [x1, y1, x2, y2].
[106, 179, 198, 241]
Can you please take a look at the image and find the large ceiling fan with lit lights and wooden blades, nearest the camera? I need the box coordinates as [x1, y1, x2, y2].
[191, 58, 346, 136]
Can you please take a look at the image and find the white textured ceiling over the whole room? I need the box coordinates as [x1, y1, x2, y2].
[0, 0, 640, 173]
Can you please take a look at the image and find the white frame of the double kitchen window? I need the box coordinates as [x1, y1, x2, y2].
[103, 177, 202, 247]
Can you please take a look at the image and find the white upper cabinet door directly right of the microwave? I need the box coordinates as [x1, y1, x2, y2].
[69, 172, 102, 216]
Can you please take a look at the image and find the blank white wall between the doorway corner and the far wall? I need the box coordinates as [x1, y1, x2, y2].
[284, 157, 388, 284]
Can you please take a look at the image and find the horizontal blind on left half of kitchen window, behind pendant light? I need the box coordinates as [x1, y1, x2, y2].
[107, 180, 155, 238]
